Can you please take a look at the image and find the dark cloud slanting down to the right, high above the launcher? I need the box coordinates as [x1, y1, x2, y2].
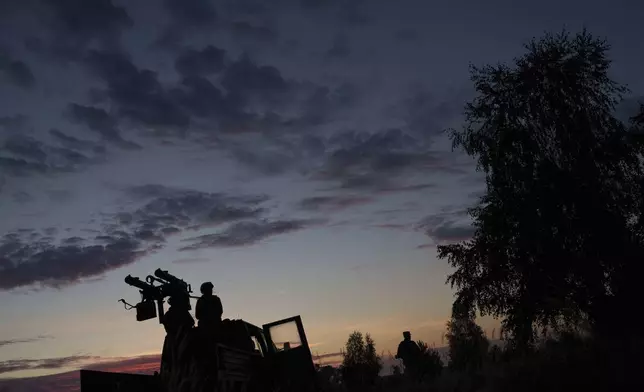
[85, 50, 190, 133]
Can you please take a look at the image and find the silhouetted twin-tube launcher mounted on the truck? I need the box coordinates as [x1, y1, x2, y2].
[119, 268, 195, 323]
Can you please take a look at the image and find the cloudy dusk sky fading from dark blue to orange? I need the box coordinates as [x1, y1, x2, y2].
[0, 0, 644, 392]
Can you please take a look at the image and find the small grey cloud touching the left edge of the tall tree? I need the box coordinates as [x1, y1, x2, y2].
[419, 210, 475, 245]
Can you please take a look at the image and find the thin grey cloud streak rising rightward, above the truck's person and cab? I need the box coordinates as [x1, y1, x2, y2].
[179, 220, 320, 251]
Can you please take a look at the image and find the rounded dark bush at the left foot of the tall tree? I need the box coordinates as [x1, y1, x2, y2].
[445, 312, 489, 371]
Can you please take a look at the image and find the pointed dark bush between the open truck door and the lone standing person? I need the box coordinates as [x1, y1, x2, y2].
[340, 331, 382, 389]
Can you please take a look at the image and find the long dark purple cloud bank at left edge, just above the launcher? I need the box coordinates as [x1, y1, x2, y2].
[0, 233, 147, 290]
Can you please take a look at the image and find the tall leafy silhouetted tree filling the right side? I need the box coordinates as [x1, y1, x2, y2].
[438, 30, 644, 348]
